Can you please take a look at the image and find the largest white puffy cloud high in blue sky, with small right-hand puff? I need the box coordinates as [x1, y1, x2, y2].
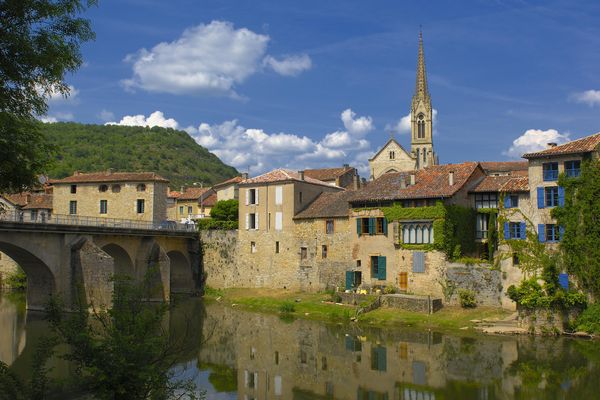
[122, 21, 311, 97]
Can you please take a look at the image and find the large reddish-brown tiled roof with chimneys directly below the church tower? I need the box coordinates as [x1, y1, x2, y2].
[350, 162, 483, 202]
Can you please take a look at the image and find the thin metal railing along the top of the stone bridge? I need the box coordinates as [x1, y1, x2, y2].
[0, 210, 196, 232]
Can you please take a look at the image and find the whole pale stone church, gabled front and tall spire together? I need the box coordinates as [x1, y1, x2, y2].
[369, 33, 438, 180]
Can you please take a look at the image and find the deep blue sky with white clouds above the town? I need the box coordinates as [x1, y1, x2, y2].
[41, 0, 600, 177]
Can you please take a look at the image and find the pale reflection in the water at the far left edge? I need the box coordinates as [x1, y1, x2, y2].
[0, 296, 26, 365]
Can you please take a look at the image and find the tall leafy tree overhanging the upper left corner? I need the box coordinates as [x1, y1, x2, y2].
[0, 0, 96, 191]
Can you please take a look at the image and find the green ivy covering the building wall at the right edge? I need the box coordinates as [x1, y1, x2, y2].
[552, 160, 600, 298]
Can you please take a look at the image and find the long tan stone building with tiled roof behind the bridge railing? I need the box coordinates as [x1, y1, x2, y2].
[50, 170, 169, 223]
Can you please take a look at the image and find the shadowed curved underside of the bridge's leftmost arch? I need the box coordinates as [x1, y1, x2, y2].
[0, 242, 56, 310]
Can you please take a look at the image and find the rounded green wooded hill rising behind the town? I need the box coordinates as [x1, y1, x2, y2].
[41, 122, 238, 190]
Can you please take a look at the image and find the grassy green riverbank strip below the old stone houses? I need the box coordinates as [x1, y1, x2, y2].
[205, 289, 510, 330]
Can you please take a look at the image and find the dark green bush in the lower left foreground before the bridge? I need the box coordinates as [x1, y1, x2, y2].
[47, 277, 204, 400]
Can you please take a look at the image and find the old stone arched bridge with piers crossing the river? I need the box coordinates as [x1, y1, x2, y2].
[0, 221, 202, 310]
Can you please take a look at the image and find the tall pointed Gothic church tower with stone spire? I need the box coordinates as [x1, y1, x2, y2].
[410, 32, 437, 169]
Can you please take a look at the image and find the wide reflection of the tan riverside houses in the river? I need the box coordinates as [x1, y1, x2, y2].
[200, 305, 517, 400]
